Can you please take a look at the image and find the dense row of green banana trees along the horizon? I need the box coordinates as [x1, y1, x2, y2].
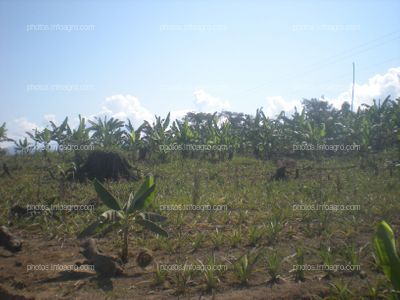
[0, 96, 400, 160]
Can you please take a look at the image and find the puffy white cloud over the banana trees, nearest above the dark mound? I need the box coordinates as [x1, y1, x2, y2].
[95, 95, 153, 125]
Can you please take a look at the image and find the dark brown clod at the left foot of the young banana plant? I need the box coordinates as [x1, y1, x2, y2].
[80, 239, 123, 277]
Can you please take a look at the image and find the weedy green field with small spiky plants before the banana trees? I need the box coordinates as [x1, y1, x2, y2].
[0, 153, 400, 299]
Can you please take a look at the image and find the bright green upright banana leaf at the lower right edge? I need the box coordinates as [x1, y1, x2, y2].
[374, 221, 400, 299]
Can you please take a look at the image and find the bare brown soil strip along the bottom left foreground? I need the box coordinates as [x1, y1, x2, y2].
[0, 230, 328, 300]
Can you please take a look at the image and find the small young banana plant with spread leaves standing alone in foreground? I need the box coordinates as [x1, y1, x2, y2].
[78, 176, 168, 263]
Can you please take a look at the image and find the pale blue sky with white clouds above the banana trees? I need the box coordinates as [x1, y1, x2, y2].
[0, 0, 400, 140]
